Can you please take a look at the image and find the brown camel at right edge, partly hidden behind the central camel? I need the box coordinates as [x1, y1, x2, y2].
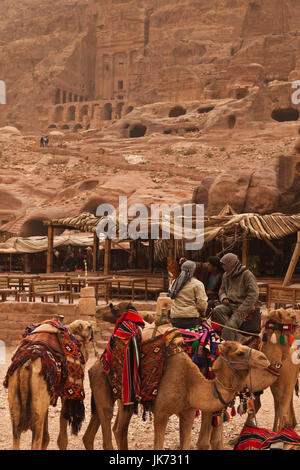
[197, 309, 299, 450]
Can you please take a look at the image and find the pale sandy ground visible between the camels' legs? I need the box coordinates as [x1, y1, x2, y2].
[0, 349, 300, 450]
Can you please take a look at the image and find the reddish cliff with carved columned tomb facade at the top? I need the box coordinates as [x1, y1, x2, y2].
[0, 0, 300, 133]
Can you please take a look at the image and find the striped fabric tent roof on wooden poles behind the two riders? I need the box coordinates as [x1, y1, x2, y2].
[45, 205, 300, 278]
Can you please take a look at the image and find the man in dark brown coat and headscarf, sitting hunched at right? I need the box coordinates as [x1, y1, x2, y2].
[213, 253, 259, 341]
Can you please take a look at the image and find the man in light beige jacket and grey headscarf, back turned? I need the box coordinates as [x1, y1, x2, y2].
[170, 261, 207, 329]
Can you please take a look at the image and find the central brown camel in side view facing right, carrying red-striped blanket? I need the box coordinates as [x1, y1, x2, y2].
[83, 336, 269, 450]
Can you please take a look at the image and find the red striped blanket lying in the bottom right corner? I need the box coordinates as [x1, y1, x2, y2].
[234, 425, 300, 450]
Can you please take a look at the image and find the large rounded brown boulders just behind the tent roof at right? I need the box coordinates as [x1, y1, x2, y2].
[192, 156, 300, 215]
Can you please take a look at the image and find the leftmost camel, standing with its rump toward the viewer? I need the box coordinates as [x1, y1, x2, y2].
[8, 320, 93, 450]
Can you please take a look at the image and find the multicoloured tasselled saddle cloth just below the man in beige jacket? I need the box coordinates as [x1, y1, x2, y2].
[179, 321, 223, 379]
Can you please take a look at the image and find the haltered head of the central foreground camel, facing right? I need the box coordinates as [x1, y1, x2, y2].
[213, 341, 270, 371]
